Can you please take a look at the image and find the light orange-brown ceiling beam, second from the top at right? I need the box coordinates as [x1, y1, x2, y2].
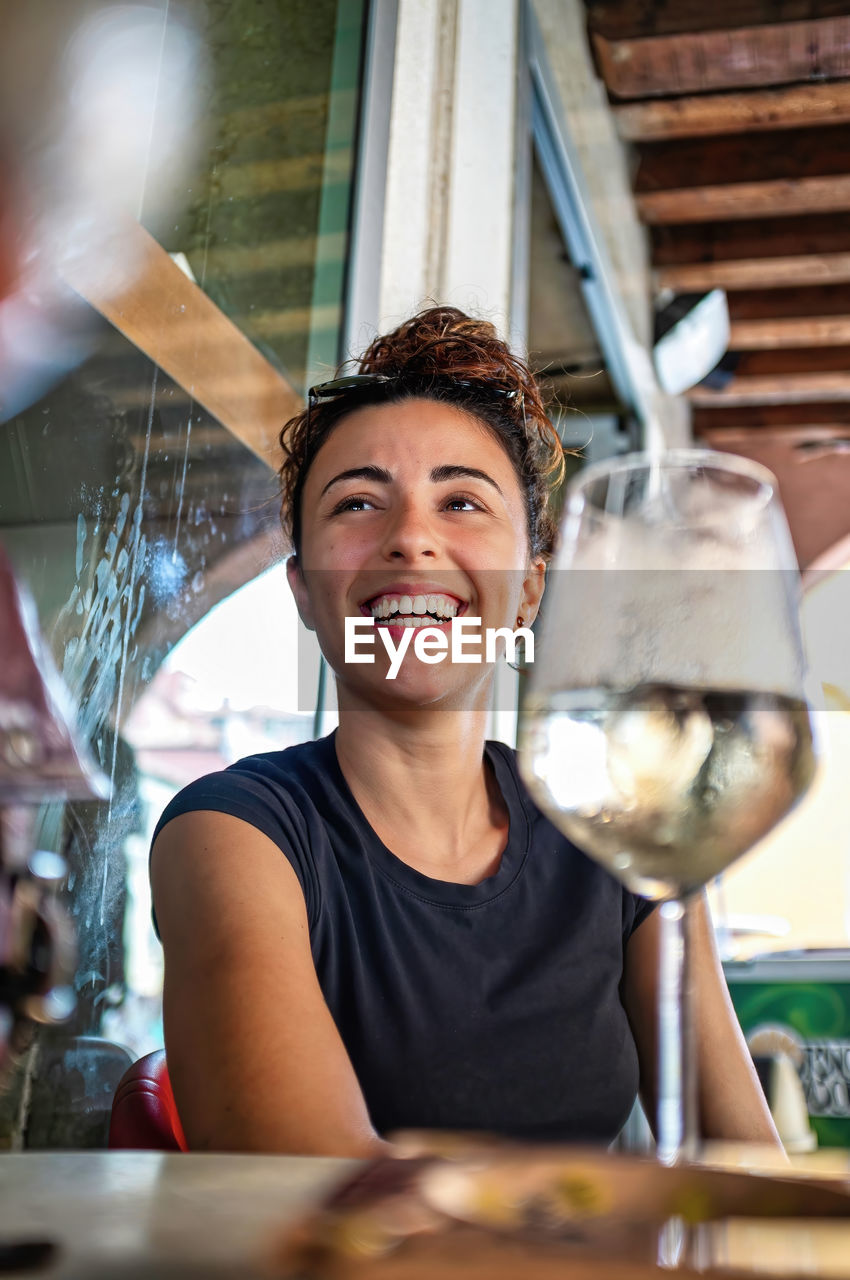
[613, 81, 850, 142]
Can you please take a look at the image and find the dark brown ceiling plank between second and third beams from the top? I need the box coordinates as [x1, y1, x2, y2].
[635, 124, 850, 192]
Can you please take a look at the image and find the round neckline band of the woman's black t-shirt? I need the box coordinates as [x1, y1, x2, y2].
[318, 730, 531, 910]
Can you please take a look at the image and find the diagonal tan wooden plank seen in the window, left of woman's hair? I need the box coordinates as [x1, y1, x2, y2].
[63, 219, 303, 467]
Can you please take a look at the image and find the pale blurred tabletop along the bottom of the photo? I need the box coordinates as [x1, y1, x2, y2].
[0, 1148, 850, 1280]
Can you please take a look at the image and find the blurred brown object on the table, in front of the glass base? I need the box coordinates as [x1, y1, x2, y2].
[270, 1133, 850, 1280]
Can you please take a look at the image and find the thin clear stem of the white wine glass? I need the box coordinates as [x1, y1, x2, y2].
[658, 895, 699, 1165]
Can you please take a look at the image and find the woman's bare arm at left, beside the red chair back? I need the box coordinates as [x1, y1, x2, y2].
[151, 812, 387, 1156]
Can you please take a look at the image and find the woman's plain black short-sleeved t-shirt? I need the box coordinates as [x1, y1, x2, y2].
[156, 735, 652, 1142]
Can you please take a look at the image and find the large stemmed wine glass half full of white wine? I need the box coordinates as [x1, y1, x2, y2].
[520, 449, 814, 1165]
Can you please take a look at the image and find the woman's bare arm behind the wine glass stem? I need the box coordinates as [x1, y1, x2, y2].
[622, 896, 781, 1146]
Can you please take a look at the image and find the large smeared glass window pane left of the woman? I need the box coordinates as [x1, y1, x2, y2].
[0, 0, 365, 1147]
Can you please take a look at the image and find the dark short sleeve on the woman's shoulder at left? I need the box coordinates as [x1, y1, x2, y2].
[151, 765, 319, 937]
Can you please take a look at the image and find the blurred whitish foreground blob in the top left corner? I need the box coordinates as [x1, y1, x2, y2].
[0, 0, 200, 422]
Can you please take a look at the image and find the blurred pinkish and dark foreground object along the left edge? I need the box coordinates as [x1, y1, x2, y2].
[0, 548, 109, 1073]
